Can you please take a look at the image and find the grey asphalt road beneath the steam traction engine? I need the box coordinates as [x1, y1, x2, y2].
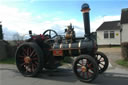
[0, 65, 128, 85]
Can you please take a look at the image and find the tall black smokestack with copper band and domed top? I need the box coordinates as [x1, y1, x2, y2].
[81, 3, 90, 36]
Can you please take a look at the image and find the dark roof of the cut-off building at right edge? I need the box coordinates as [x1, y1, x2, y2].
[121, 8, 128, 24]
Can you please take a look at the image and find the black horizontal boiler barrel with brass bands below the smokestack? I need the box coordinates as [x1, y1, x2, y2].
[53, 40, 94, 56]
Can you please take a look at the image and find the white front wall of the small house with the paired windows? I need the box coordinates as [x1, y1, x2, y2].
[97, 30, 120, 45]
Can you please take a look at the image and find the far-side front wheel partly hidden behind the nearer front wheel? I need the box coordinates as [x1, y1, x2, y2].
[96, 52, 109, 74]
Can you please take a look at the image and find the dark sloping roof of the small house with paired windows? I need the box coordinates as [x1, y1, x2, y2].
[96, 21, 121, 31]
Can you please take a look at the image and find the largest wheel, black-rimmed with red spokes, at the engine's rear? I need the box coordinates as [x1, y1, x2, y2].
[15, 43, 43, 77]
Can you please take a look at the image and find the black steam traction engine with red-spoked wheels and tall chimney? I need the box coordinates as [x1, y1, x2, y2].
[15, 3, 108, 82]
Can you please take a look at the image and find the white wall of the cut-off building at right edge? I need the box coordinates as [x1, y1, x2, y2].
[122, 24, 128, 42]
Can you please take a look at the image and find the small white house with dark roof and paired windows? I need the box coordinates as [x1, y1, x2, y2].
[96, 21, 121, 45]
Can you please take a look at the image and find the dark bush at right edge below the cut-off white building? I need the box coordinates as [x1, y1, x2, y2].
[121, 42, 128, 60]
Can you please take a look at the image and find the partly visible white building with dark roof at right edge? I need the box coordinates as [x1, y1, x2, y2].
[121, 8, 128, 42]
